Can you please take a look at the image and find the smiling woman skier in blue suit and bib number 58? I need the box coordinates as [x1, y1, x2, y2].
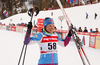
[28, 18, 71, 65]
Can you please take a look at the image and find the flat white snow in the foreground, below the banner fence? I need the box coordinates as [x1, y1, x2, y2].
[0, 30, 100, 65]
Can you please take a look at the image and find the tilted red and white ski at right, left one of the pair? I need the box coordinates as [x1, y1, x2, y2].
[56, 0, 90, 65]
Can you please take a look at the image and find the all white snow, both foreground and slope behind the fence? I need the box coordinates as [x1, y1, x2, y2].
[0, 3, 100, 65]
